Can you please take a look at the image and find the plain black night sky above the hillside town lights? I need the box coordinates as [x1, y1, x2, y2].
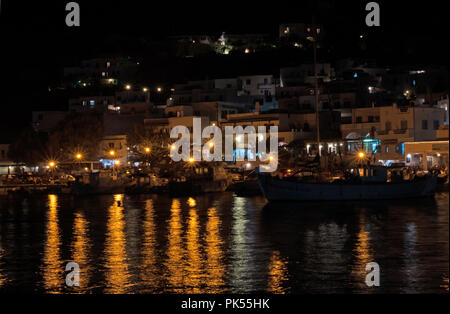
[0, 0, 448, 137]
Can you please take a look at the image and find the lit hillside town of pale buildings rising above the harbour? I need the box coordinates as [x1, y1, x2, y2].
[0, 23, 449, 194]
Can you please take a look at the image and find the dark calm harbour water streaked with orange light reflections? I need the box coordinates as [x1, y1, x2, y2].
[0, 193, 449, 293]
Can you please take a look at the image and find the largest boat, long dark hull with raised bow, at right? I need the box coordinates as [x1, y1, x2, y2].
[258, 166, 437, 201]
